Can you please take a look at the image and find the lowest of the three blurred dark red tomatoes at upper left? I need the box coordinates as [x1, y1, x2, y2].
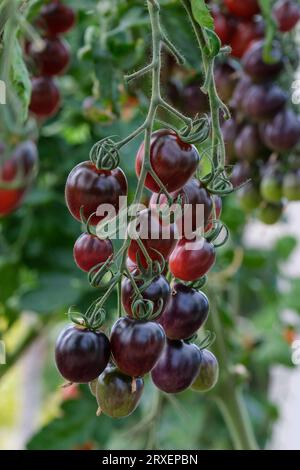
[29, 77, 60, 118]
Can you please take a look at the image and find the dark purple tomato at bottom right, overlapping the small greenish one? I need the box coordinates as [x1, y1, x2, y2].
[151, 339, 202, 393]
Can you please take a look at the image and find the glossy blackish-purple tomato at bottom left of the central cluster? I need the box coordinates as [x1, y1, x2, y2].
[55, 326, 110, 383]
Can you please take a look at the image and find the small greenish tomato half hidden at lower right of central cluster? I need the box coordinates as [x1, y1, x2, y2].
[192, 349, 219, 392]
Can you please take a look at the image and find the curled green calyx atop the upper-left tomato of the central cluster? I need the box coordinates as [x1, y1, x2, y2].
[90, 137, 120, 171]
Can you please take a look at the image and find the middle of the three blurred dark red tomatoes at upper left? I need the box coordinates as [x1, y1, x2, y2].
[28, 38, 70, 77]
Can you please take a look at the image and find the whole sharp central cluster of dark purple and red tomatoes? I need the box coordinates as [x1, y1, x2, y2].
[56, 129, 222, 417]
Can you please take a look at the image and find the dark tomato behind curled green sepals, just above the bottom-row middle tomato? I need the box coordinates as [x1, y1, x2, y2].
[122, 270, 171, 317]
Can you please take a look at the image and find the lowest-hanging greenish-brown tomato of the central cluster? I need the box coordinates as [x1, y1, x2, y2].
[96, 366, 144, 418]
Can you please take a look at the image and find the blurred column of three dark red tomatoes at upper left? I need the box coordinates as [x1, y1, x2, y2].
[25, 0, 75, 119]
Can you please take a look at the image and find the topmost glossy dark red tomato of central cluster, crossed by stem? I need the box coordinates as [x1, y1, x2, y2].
[136, 129, 200, 193]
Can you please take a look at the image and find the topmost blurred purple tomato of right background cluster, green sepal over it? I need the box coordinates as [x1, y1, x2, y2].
[242, 41, 283, 82]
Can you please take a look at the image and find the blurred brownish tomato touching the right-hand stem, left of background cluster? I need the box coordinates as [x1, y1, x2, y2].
[214, 60, 238, 103]
